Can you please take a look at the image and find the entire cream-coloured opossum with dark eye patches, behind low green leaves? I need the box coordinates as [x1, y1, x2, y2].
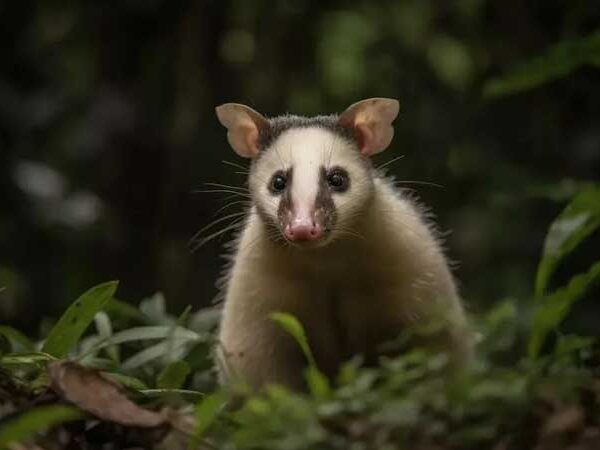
[217, 98, 471, 388]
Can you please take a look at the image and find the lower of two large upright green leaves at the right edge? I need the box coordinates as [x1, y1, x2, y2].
[528, 261, 600, 358]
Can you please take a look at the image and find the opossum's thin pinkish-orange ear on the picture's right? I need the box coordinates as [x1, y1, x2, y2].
[338, 98, 400, 156]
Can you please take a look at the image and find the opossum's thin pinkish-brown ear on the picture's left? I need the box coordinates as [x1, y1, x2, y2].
[215, 103, 269, 158]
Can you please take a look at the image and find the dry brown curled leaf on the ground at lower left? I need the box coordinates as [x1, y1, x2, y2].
[48, 361, 165, 427]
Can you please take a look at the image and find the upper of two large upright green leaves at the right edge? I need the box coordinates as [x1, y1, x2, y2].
[535, 185, 600, 298]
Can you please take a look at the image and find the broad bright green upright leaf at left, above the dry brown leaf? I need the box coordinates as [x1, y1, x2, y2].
[42, 281, 118, 358]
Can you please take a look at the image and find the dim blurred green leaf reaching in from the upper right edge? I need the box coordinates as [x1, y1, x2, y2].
[483, 31, 600, 97]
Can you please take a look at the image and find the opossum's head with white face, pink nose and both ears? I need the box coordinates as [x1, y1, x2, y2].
[216, 98, 399, 247]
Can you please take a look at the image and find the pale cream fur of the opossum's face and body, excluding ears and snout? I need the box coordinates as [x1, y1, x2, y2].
[218, 127, 471, 387]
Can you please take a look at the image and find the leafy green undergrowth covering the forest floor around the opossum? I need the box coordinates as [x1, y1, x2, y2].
[0, 185, 600, 450]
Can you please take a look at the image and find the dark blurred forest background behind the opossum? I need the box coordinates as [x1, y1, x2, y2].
[0, 0, 600, 334]
